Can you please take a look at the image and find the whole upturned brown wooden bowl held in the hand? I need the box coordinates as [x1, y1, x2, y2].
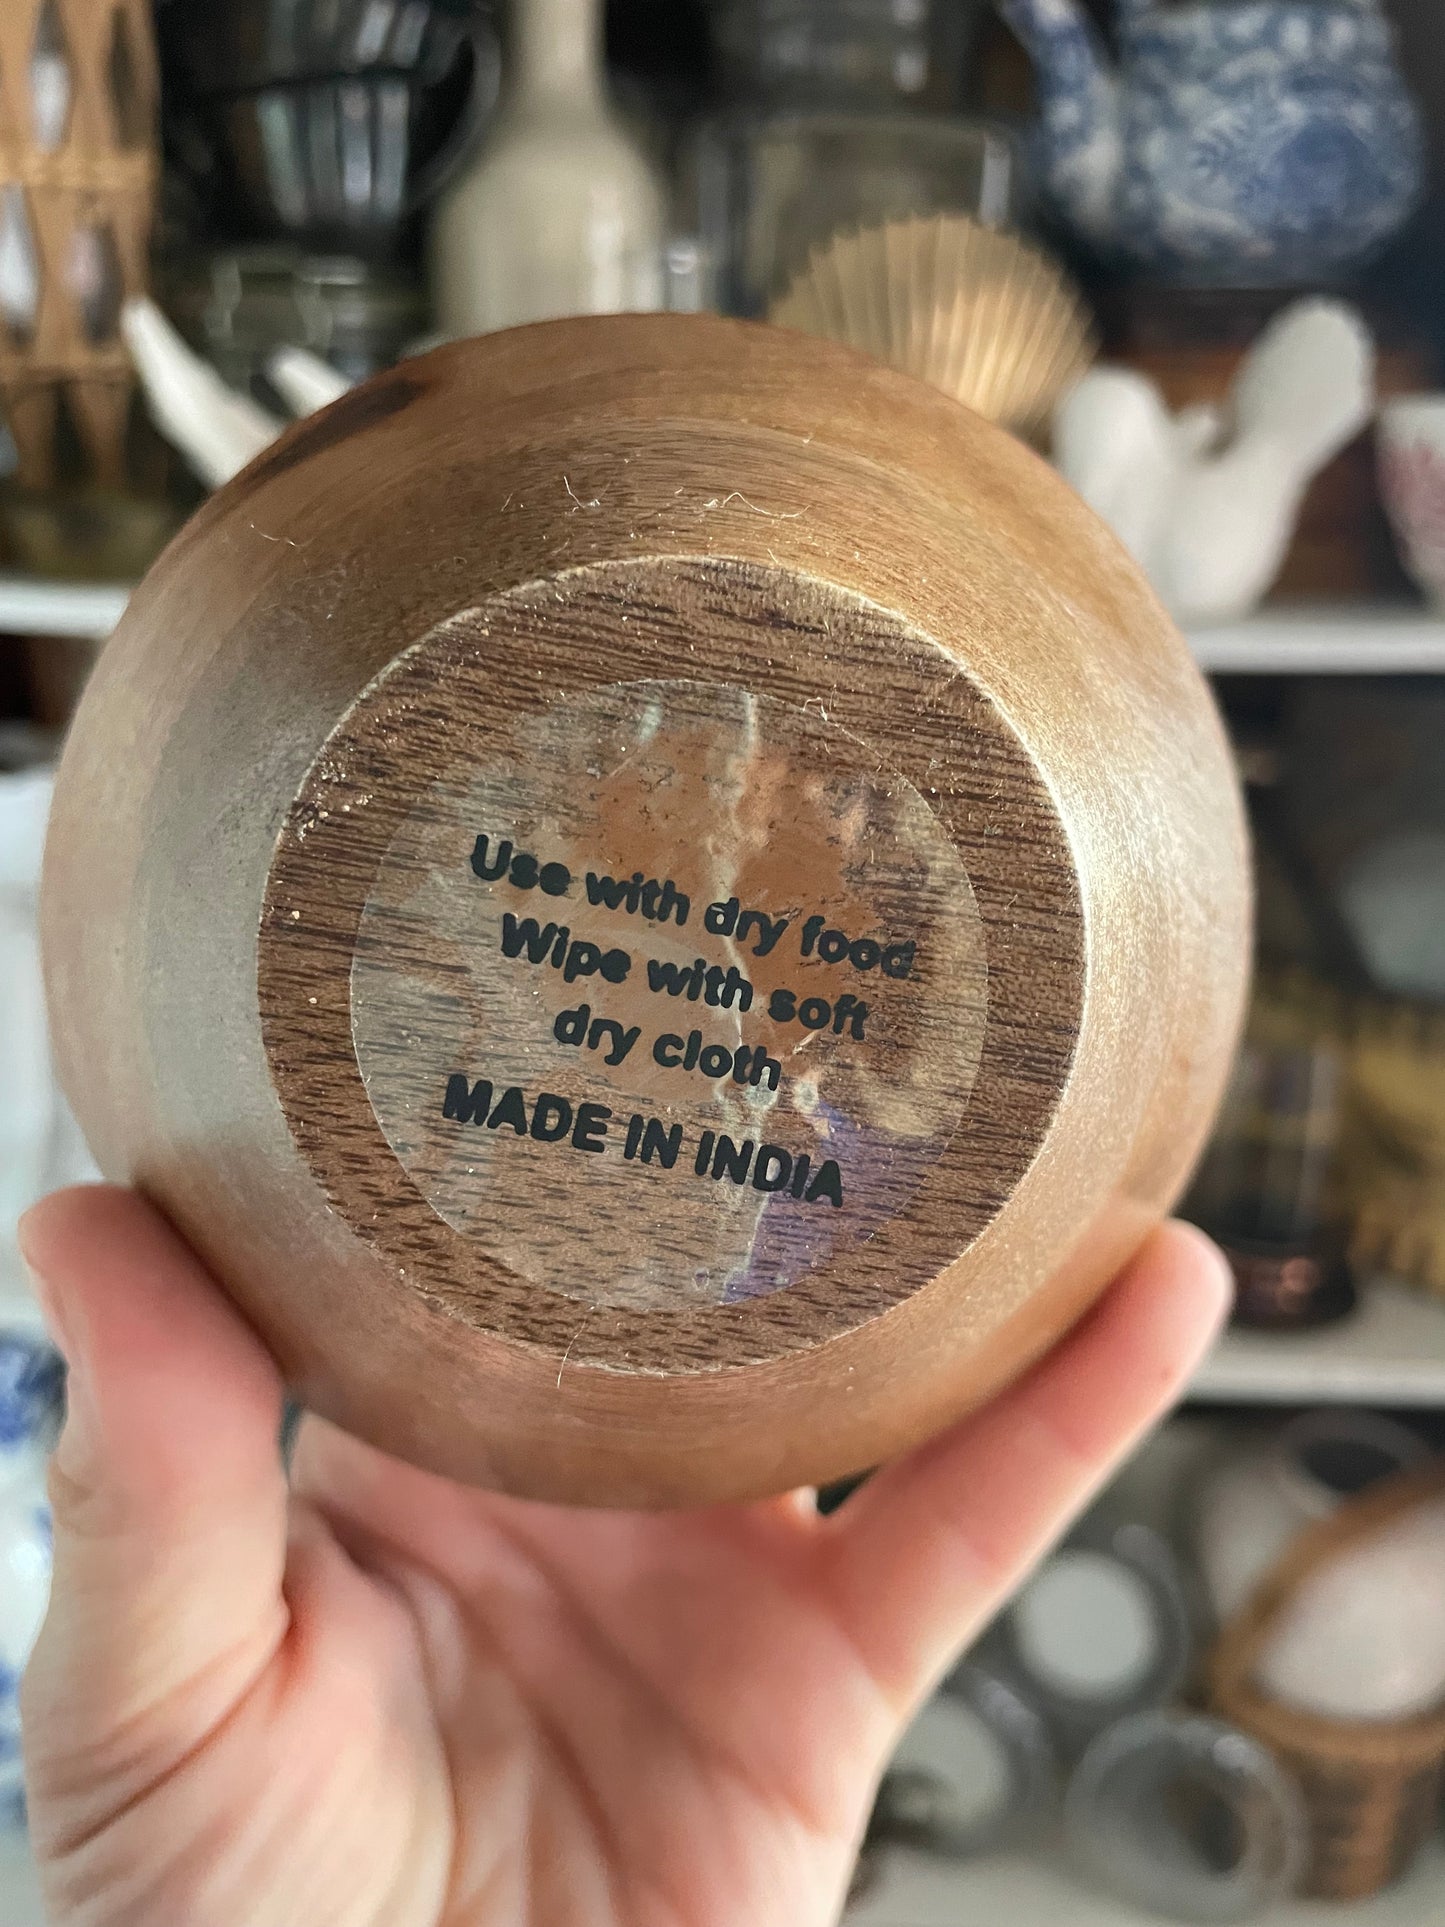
[44, 316, 1248, 1505]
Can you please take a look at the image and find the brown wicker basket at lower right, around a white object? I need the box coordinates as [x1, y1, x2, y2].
[1208, 1463, 1445, 1900]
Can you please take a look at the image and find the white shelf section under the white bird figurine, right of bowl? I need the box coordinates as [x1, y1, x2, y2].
[1189, 605, 1445, 676]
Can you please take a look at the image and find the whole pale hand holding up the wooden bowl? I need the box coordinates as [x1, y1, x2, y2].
[21, 1187, 1227, 1927]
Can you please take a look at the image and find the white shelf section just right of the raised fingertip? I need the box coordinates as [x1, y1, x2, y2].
[1191, 1280, 1445, 1410]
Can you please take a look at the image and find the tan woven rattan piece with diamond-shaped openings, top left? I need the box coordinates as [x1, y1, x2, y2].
[0, 0, 158, 489]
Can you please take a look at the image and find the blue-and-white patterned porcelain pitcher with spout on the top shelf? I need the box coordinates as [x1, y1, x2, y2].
[1000, 0, 1424, 287]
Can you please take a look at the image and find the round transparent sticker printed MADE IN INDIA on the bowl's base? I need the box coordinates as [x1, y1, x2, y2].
[351, 680, 986, 1310]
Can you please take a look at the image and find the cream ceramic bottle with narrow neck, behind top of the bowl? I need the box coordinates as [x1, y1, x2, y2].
[432, 0, 667, 335]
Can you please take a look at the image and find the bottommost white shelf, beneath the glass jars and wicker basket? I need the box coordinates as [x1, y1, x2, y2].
[844, 1848, 1445, 1927]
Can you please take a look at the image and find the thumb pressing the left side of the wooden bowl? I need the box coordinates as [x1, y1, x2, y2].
[19, 1185, 287, 1838]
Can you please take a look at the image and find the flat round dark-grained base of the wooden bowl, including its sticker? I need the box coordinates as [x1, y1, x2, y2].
[260, 559, 1083, 1374]
